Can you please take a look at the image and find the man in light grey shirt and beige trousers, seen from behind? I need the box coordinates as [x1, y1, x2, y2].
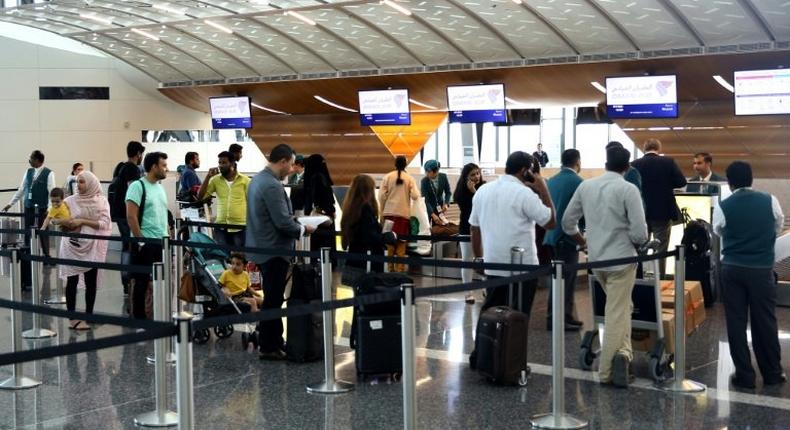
[562, 147, 647, 388]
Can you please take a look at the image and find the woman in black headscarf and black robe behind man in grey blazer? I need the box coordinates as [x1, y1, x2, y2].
[304, 154, 336, 252]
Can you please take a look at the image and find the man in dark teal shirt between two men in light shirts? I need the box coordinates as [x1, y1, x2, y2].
[543, 149, 582, 331]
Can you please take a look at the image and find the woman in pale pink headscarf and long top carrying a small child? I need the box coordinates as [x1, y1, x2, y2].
[58, 171, 112, 330]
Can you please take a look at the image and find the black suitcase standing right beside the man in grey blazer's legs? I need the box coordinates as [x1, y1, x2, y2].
[285, 263, 324, 363]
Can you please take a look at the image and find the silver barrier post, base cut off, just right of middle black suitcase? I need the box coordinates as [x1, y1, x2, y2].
[400, 284, 417, 430]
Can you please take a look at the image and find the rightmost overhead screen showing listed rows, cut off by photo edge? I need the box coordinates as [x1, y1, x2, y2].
[734, 69, 790, 115]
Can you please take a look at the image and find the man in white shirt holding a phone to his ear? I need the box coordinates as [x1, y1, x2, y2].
[469, 151, 556, 316]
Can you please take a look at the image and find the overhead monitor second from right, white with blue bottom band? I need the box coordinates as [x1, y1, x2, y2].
[606, 75, 678, 118]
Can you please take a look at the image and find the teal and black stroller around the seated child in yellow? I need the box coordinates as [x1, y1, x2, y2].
[184, 232, 258, 349]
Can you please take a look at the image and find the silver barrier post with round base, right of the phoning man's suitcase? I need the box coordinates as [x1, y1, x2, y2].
[530, 261, 589, 430]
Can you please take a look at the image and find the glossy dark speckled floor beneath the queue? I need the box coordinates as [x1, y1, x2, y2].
[0, 254, 790, 429]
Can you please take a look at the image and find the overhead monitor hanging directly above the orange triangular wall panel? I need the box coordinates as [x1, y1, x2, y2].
[359, 89, 411, 126]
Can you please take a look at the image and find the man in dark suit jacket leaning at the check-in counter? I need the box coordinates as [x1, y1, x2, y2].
[632, 139, 686, 275]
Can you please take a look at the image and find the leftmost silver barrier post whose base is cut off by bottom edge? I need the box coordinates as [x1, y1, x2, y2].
[173, 312, 195, 430]
